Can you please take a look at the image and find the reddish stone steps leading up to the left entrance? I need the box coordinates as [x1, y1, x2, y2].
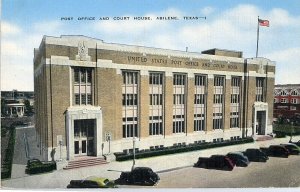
[63, 157, 108, 170]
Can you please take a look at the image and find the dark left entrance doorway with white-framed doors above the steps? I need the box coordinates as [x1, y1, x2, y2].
[74, 119, 96, 156]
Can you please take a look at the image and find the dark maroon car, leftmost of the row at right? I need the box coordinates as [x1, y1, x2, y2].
[194, 155, 235, 171]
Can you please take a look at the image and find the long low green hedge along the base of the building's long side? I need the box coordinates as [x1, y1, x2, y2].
[114, 137, 254, 161]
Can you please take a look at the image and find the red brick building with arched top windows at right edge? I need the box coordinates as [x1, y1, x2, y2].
[274, 84, 300, 119]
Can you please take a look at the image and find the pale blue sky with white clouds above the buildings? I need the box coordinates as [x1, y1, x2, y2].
[1, 0, 300, 90]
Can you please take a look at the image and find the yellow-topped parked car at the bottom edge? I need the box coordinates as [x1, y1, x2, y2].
[67, 176, 117, 188]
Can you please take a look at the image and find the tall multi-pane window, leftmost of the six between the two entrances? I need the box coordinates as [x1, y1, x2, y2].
[122, 71, 139, 138]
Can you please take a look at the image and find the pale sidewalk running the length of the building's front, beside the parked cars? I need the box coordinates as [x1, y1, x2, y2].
[2, 136, 300, 189]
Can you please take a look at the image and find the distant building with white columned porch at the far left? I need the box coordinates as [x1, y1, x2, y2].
[1, 90, 34, 117]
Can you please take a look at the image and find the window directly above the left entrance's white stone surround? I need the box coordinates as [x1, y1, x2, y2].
[73, 67, 92, 105]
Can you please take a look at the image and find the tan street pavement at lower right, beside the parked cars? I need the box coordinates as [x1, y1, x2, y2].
[156, 155, 300, 188]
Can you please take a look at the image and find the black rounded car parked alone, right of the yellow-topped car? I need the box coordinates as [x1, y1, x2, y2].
[120, 167, 160, 185]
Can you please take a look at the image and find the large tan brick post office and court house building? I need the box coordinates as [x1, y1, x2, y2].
[34, 36, 275, 160]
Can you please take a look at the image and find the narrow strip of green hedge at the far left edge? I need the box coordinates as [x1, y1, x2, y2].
[1, 127, 16, 179]
